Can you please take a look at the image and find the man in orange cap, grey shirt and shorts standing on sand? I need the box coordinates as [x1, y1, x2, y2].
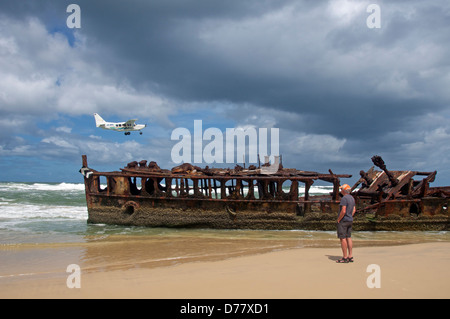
[336, 184, 356, 263]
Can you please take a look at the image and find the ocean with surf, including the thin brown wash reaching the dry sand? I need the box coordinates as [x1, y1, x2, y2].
[0, 182, 450, 277]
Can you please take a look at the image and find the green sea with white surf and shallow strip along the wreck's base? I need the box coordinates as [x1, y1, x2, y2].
[0, 182, 450, 244]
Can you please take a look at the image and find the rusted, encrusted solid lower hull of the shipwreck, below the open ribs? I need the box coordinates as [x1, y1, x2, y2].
[88, 196, 450, 231]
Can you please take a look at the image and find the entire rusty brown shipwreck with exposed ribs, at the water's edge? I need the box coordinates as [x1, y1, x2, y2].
[80, 155, 450, 230]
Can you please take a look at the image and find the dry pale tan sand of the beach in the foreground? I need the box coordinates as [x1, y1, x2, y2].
[0, 242, 450, 299]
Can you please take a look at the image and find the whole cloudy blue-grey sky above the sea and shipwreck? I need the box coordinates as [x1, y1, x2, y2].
[0, 0, 450, 186]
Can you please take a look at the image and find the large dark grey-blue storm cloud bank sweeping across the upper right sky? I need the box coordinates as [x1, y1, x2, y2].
[67, 1, 450, 144]
